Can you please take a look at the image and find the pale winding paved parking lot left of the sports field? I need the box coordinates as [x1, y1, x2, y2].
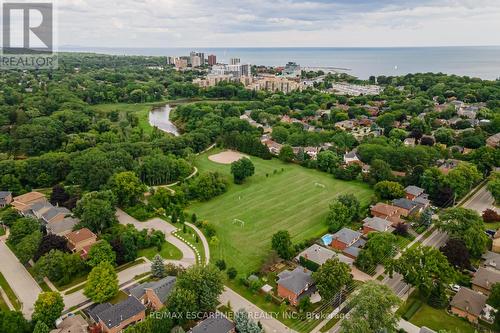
[116, 208, 196, 265]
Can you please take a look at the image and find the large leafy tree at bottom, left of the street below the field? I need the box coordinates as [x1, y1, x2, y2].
[176, 265, 224, 312]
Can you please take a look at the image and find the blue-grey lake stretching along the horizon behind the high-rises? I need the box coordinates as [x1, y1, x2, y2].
[60, 46, 500, 80]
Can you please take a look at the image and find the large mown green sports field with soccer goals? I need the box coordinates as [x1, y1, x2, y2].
[190, 149, 373, 274]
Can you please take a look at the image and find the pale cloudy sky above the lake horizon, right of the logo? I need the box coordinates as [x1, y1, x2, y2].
[53, 0, 500, 48]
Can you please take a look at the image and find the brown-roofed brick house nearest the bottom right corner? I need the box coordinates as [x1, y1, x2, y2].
[450, 287, 488, 323]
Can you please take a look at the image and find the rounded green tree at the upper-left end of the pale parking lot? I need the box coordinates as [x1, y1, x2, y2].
[108, 171, 146, 207]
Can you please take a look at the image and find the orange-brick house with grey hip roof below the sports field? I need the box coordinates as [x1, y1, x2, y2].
[277, 266, 316, 305]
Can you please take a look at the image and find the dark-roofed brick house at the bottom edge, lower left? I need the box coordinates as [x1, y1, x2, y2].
[88, 296, 146, 333]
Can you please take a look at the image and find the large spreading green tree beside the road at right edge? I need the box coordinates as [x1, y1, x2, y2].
[436, 207, 488, 258]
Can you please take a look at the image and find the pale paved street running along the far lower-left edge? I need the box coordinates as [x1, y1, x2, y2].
[0, 240, 42, 318]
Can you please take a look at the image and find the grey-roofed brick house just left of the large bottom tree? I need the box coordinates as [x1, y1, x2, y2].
[130, 276, 176, 311]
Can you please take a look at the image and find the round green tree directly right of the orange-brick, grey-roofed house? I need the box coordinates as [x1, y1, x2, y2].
[312, 258, 352, 301]
